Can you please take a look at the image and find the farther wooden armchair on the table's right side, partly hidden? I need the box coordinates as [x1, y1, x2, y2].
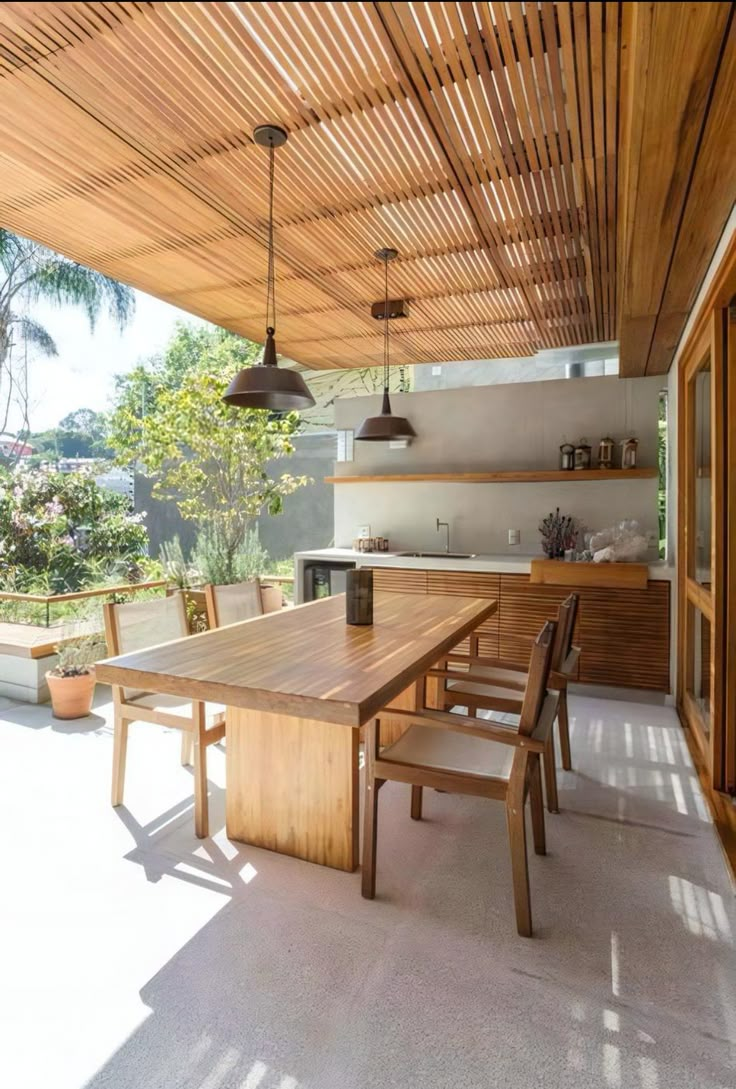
[433, 594, 580, 812]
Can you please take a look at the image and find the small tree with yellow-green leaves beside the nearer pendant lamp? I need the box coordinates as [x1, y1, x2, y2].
[108, 327, 307, 580]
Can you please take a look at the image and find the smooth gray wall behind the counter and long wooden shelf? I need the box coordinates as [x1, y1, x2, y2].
[330, 376, 665, 559]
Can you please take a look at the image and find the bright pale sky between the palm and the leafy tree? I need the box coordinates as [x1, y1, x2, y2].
[9, 291, 210, 431]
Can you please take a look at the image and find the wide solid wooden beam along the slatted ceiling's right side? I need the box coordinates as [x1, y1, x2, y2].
[618, 2, 733, 377]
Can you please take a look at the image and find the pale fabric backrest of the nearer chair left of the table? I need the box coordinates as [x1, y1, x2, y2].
[102, 592, 189, 699]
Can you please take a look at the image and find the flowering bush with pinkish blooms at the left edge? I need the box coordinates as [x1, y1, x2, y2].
[0, 469, 148, 594]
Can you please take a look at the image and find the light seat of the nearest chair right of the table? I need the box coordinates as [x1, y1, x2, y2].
[380, 726, 515, 779]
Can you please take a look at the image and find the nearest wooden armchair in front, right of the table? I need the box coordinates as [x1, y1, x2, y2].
[363, 621, 560, 938]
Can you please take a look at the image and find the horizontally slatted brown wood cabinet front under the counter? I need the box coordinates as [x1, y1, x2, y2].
[365, 567, 670, 693]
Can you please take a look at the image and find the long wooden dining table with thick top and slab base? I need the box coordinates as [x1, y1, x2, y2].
[97, 592, 498, 870]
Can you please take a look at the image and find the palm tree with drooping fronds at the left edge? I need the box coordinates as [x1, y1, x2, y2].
[0, 228, 135, 450]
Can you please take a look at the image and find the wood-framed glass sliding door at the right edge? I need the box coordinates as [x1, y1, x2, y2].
[677, 242, 736, 793]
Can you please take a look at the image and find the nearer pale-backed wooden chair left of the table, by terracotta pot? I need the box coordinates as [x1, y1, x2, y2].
[103, 594, 225, 840]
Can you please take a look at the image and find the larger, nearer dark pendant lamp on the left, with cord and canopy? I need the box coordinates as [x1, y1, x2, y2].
[222, 125, 315, 412]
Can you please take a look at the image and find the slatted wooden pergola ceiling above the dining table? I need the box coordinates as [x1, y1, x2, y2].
[0, 2, 729, 368]
